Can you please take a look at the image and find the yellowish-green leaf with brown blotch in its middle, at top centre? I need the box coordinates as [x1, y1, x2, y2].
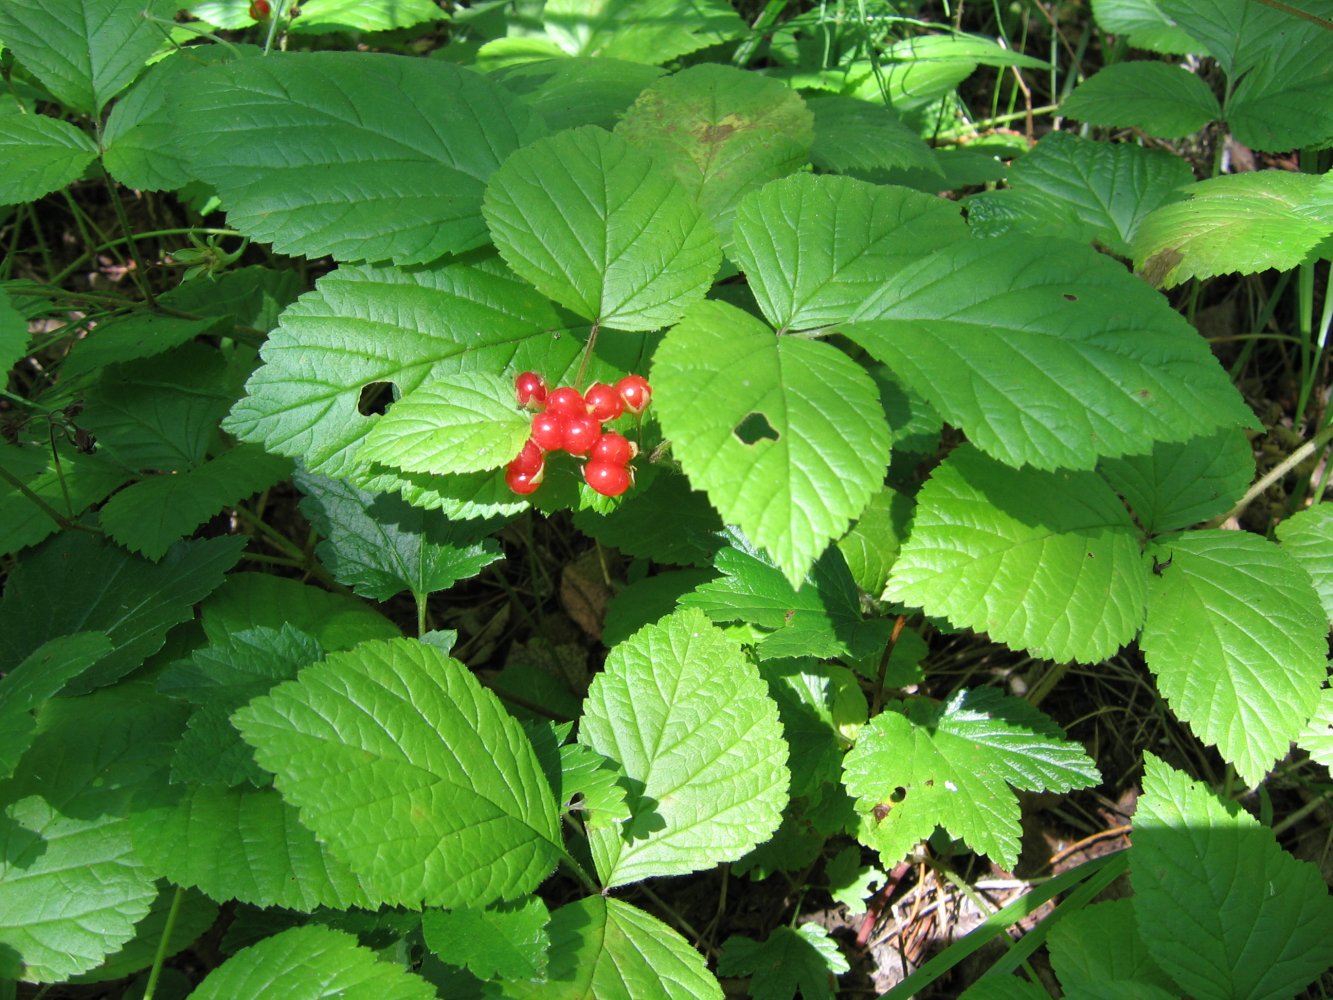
[616, 63, 814, 248]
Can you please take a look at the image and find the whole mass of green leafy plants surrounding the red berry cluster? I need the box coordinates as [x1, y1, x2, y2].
[0, 0, 1333, 1000]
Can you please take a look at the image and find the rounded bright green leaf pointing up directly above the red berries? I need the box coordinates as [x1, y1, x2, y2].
[483, 125, 721, 331]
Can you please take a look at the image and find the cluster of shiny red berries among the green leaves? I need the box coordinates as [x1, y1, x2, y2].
[504, 372, 653, 496]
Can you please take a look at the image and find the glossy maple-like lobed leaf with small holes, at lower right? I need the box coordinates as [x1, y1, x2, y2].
[842, 688, 1101, 868]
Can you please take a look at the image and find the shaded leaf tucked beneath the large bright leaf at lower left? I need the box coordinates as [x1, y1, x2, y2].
[131, 785, 381, 912]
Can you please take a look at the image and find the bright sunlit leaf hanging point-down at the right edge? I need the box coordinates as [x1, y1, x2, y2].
[1138, 531, 1328, 785]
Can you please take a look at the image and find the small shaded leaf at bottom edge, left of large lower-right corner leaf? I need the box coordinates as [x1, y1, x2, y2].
[1049, 899, 1176, 1000]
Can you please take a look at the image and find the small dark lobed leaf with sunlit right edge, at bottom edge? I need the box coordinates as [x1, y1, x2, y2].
[717, 924, 852, 1000]
